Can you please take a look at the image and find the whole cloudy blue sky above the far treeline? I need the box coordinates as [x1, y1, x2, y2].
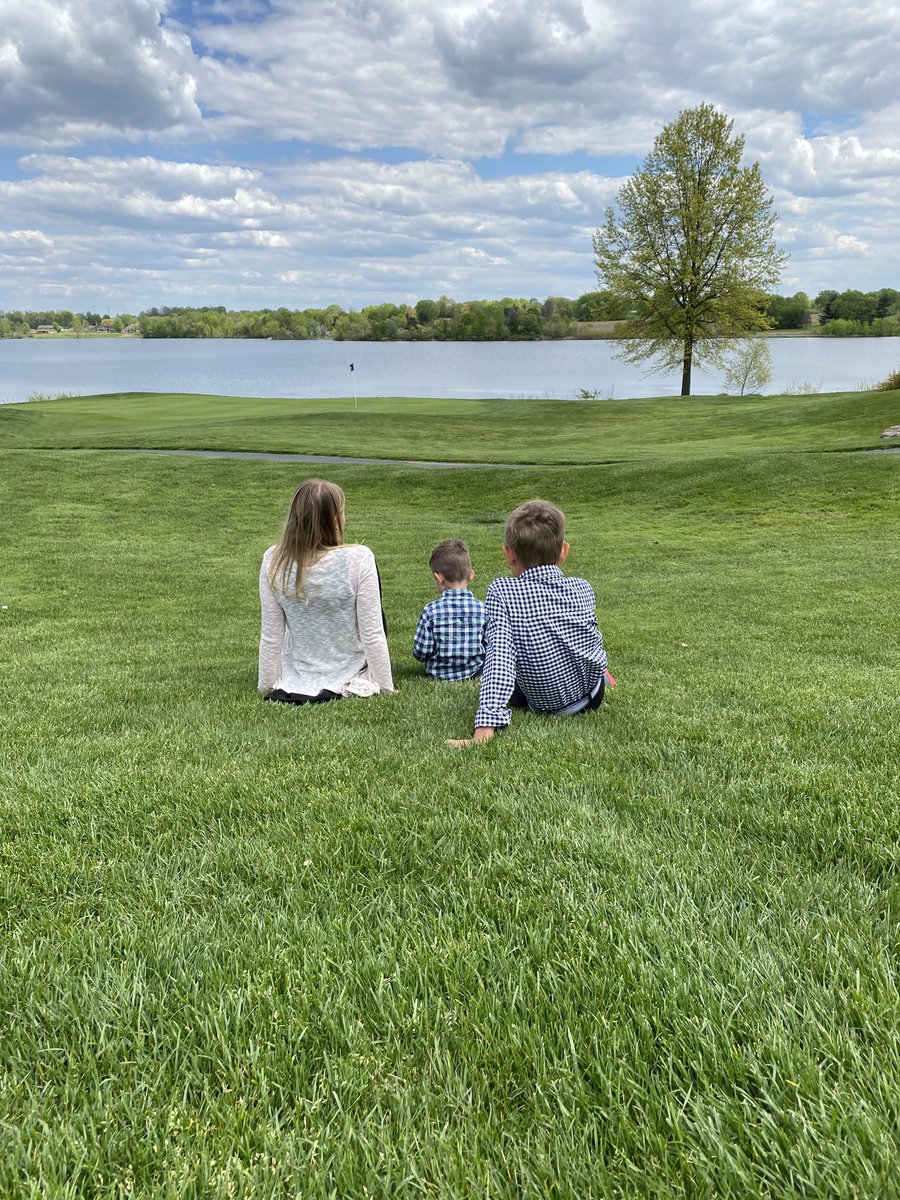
[0, 0, 900, 314]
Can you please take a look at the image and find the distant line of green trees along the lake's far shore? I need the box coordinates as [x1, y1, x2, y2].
[0, 288, 900, 342]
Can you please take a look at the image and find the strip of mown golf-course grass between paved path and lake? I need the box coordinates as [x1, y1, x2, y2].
[0, 392, 900, 463]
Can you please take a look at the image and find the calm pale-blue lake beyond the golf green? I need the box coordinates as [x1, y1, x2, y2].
[0, 337, 900, 403]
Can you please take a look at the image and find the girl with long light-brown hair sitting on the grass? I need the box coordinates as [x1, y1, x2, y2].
[258, 479, 394, 704]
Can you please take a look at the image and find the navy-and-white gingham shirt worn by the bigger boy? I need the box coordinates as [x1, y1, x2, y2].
[475, 565, 606, 728]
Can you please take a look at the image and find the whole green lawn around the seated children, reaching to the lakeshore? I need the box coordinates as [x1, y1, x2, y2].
[0, 394, 900, 1200]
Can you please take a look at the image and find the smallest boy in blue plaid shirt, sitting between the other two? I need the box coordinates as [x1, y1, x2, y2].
[413, 539, 485, 679]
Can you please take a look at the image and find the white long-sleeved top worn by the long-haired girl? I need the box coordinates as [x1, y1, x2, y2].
[259, 546, 394, 696]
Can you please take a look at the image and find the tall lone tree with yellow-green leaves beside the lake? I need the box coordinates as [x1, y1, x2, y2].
[594, 104, 787, 396]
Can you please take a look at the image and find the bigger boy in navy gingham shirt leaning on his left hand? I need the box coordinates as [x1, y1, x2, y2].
[450, 500, 606, 746]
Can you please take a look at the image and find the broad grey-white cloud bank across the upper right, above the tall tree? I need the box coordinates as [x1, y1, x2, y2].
[174, 0, 900, 157]
